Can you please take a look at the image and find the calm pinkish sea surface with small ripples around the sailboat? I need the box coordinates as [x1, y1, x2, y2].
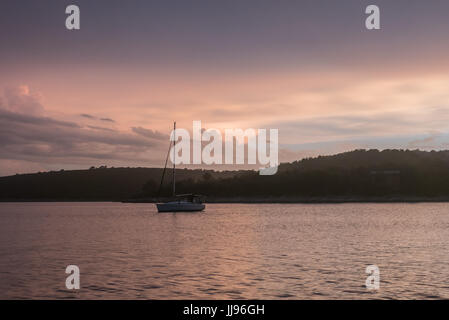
[0, 203, 449, 299]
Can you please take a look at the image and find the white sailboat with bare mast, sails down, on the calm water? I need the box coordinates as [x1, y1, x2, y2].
[156, 122, 206, 212]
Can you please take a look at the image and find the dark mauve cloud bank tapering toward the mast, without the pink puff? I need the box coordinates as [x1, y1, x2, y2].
[0, 112, 165, 164]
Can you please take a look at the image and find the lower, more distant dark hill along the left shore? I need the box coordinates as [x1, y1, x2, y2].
[0, 167, 242, 201]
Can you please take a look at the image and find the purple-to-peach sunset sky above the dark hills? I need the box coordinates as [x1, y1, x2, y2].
[0, 0, 449, 176]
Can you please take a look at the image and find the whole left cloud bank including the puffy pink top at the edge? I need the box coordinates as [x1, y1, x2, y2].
[0, 85, 168, 174]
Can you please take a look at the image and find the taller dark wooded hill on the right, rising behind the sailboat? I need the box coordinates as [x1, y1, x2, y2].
[161, 150, 449, 202]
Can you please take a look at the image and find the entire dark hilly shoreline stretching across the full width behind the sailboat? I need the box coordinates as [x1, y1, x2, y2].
[0, 150, 449, 202]
